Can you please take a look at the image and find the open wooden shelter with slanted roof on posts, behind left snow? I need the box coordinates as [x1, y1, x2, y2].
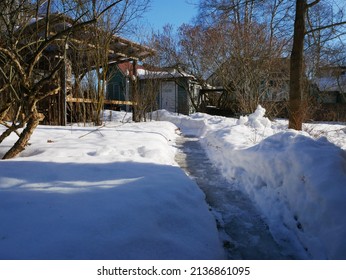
[28, 14, 154, 125]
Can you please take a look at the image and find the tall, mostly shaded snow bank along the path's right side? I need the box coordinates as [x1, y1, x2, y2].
[204, 108, 346, 259]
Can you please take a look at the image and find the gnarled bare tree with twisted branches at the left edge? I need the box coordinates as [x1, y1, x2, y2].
[0, 0, 147, 159]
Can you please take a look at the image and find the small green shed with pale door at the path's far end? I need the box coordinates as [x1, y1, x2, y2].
[106, 62, 200, 115]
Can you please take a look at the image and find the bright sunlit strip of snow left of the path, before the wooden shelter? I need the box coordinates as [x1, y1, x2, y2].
[12, 121, 177, 165]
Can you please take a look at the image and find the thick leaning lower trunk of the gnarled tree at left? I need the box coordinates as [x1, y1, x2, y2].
[2, 112, 44, 159]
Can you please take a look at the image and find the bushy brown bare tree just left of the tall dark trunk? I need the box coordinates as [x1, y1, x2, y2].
[193, 0, 290, 116]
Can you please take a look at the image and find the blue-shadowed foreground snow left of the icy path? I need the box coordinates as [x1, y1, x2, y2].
[0, 161, 223, 259]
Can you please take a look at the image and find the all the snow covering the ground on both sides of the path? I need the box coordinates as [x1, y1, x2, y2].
[0, 107, 346, 259]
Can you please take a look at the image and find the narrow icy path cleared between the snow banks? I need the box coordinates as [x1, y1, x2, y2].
[176, 137, 295, 260]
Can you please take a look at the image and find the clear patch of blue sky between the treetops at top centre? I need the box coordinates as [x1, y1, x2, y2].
[143, 0, 197, 31]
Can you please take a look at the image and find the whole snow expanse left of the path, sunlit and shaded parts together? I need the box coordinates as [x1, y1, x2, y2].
[0, 120, 224, 259]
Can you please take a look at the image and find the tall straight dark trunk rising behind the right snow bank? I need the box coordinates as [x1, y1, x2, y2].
[288, 0, 307, 130]
